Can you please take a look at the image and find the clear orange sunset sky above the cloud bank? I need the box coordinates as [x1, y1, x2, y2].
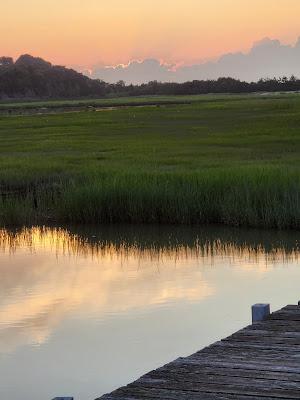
[0, 0, 300, 66]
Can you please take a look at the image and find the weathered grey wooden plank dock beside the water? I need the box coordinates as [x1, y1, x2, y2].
[101, 306, 300, 400]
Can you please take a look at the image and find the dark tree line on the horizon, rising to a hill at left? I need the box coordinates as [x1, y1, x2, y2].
[0, 55, 300, 100]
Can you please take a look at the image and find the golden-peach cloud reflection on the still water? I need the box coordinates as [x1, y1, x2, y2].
[0, 228, 215, 354]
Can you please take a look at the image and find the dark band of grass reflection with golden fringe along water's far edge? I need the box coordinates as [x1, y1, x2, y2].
[0, 226, 299, 263]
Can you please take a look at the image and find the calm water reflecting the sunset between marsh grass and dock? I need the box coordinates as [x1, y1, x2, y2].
[0, 226, 300, 400]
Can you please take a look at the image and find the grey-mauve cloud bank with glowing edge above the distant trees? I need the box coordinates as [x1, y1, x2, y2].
[91, 38, 300, 84]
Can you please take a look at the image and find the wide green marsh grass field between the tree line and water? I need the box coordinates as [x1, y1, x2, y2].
[0, 95, 300, 229]
